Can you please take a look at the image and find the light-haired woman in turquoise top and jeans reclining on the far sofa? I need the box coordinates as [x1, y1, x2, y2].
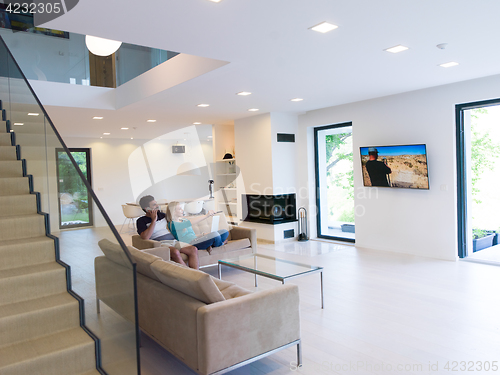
[167, 202, 229, 253]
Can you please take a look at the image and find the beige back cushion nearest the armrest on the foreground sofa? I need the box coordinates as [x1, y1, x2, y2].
[151, 261, 225, 304]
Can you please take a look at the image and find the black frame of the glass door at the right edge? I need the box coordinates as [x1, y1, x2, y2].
[455, 98, 500, 258]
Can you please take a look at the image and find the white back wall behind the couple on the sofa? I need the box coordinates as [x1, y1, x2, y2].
[65, 132, 213, 227]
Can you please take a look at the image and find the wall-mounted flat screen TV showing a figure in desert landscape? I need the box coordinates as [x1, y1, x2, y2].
[360, 144, 429, 189]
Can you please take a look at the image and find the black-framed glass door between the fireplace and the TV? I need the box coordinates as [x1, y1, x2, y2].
[314, 122, 355, 242]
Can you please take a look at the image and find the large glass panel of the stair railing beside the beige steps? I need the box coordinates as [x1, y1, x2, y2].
[0, 33, 140, 375]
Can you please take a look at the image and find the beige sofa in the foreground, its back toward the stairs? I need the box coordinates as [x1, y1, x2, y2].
[95, 240, 301, 375]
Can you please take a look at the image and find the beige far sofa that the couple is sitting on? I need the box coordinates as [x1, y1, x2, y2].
[132, 214, 257, 267]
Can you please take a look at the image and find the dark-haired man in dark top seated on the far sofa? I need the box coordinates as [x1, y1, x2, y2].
[137, 195, 198, 269]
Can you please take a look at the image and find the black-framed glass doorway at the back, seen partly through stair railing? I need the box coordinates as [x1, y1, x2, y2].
[56, 148, 93, 229]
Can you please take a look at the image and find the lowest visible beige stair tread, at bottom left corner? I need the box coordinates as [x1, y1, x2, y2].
[0, 327, 94, 373]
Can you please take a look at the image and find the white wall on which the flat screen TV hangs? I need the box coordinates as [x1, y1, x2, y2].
[298, 73, 500, 260]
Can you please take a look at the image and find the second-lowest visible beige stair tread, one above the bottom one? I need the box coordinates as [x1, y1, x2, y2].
[0, 292, 78, 319]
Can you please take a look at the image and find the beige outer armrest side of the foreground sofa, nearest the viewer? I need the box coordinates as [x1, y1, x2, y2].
[197, 285, 300, 374]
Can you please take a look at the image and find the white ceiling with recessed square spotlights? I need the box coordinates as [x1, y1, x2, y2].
[37, 0, 500, 137]
